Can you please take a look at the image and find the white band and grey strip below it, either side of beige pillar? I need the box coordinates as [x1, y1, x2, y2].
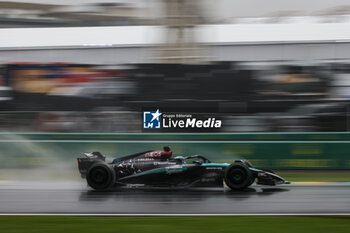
[0, 23, 350, 64]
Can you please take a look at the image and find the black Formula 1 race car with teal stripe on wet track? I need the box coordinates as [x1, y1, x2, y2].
[77, 147, 289, 190]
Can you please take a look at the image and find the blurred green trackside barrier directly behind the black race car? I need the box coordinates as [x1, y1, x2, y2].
[0, 132, 350, 169]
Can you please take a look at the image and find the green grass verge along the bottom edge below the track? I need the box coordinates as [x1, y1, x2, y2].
[0, 216, 350, 233]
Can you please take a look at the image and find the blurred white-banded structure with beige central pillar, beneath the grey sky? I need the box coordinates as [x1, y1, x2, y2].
[0, 0, 350, 65]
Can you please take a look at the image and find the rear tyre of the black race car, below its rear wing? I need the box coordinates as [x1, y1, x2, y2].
[86, 162, 116, 190]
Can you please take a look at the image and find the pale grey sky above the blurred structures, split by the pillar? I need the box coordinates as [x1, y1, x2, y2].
[2, 0, 350, 19]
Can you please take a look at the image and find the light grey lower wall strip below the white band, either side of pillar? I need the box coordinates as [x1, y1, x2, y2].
[0, 42, 350, 64]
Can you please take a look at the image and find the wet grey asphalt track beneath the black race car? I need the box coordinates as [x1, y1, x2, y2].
[0, 182, 350, 214]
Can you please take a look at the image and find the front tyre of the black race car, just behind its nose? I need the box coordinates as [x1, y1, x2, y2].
[224, 163, 254, 190]
